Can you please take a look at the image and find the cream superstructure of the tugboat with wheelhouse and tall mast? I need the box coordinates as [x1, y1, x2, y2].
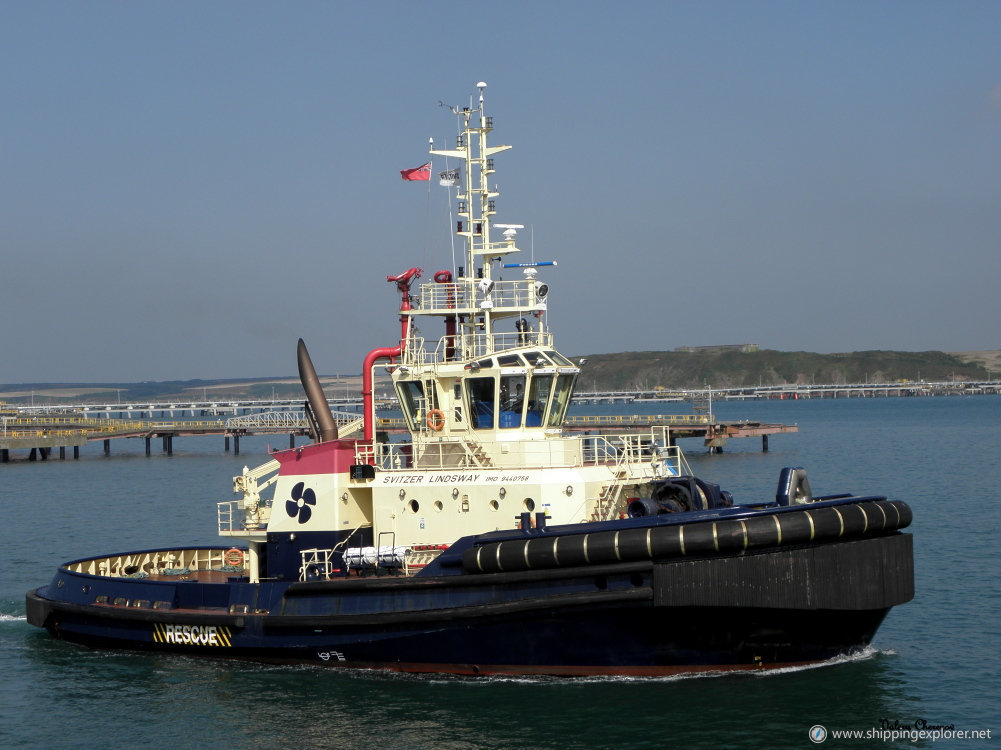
[219, 84, 690, 578]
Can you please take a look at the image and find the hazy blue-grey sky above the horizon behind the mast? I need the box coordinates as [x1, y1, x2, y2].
[0, 0, 1001, 383]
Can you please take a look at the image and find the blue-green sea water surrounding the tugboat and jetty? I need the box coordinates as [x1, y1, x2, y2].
[0, 396, 1001, 750]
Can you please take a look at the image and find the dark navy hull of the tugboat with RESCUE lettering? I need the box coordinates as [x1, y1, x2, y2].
[27, 499, 914, 675]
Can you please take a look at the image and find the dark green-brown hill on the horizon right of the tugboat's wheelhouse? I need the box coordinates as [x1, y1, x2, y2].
[575, 349, 1001, 391]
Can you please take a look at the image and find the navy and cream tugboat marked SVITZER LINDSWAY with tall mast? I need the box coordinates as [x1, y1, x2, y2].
[26, 83, 914, 675]
